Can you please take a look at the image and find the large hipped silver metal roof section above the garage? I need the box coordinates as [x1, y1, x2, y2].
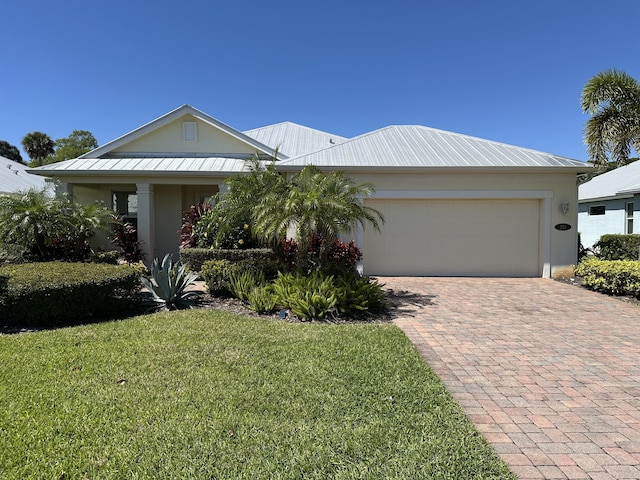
[279, 125, 591, 171]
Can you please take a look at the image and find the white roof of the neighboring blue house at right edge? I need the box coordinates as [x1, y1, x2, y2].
[578, 160, 640, 202]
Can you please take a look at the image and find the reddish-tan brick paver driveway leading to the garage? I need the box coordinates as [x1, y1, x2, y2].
[380, 277, 640, 479]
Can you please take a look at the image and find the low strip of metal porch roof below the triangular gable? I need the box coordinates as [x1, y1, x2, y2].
[31, 157, 245, 175]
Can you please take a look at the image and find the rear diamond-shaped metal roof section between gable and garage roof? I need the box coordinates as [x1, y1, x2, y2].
[243, 122, 347, 157]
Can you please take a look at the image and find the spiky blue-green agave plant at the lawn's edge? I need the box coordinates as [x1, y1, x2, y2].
[140, 253, 199, 310]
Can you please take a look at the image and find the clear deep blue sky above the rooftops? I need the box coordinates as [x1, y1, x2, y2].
[0, 0, 640, 160]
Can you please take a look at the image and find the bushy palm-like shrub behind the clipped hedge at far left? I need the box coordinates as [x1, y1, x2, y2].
[0, 189, 113, 261]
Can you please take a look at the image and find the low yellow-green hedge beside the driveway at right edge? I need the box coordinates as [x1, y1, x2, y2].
[575, 258, 640, 297]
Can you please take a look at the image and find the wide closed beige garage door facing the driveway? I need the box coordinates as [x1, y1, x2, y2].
[363, 199, 541, 277]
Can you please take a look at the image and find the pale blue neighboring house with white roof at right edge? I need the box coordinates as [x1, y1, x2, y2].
[578, 161, 640, 247]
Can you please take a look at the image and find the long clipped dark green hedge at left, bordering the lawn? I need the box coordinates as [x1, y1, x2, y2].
[0, 262, 140, 326]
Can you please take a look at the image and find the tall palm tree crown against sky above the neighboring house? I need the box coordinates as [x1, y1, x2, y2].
[580, 69, 640, 168]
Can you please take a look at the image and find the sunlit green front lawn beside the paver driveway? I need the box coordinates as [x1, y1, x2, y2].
[0, 310, 515, 479]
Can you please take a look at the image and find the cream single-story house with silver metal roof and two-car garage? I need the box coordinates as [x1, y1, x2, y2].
[32, 105, 591, 277]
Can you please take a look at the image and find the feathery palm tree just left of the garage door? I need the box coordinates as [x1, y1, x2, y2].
[253, 165, 384, 268]
